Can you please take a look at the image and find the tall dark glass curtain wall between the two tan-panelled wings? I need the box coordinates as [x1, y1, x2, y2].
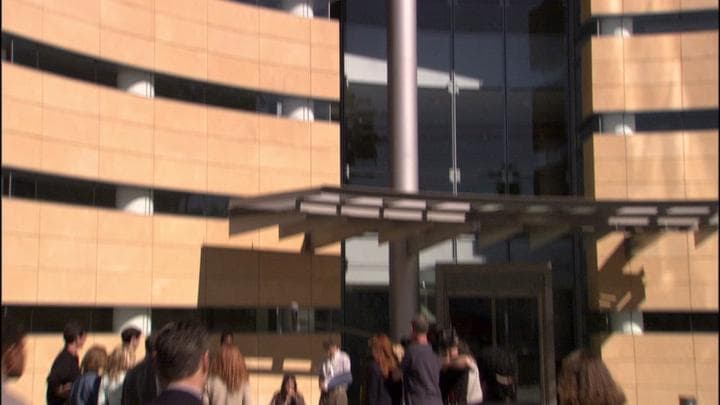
[341, 0, 577, 400]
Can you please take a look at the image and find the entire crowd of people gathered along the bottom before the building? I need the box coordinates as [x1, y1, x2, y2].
[2, 315, 625, 405]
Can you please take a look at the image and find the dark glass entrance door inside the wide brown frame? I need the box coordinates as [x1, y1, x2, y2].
[448, 296, 543, 404]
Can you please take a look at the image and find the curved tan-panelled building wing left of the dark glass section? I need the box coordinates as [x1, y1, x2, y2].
[2, 0, 341, 404]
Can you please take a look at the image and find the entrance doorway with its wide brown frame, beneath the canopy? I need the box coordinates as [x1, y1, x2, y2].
[436, 264, 556, 404]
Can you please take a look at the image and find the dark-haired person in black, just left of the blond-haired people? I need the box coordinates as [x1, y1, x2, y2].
[45, 320, 87, 405]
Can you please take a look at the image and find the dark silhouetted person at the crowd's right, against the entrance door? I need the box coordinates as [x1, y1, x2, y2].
[480, 346, 519, 402]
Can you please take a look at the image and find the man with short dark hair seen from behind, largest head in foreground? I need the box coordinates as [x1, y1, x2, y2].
[152, 321, 210, 405]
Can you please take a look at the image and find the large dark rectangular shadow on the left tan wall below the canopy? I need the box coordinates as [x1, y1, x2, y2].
[198, 246, 340, 376]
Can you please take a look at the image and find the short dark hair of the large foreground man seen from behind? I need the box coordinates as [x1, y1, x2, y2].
[155, 321, 208, 384]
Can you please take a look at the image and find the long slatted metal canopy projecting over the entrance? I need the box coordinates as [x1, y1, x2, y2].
[229, 186, 718, 253]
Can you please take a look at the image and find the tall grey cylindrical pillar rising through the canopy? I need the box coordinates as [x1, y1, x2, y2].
[387, 0, 418, 339]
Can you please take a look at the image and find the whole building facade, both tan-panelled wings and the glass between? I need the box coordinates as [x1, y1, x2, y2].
[2, 0, 718, 405]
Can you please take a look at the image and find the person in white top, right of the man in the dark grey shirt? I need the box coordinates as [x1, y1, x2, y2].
[440, 335, 483, 405]
